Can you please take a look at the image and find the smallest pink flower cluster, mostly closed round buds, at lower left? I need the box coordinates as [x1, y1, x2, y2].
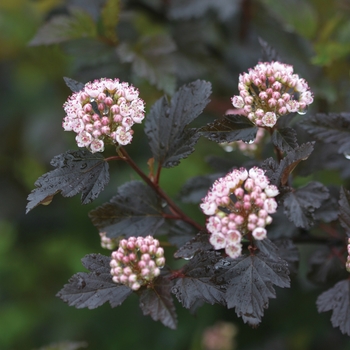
[110, 236, 165, 290]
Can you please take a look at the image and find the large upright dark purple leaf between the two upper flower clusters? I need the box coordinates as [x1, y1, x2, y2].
[145, 80, 211, 168]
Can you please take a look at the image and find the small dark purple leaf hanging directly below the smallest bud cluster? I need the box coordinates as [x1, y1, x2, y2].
[140, 277, 177, 329]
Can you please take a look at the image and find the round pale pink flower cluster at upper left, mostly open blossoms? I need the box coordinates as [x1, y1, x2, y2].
[62, 78, 145, 153]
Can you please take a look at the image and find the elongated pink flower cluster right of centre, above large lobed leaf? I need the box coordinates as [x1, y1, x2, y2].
[200, 167, 279, 258]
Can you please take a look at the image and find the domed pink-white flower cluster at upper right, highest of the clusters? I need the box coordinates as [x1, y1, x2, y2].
[231, 62, 313, 128]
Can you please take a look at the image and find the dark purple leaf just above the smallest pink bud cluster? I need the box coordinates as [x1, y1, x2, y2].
[89, 181, 164, 238]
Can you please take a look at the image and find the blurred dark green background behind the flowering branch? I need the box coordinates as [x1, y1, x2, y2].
[0, 0, 350, 350]
